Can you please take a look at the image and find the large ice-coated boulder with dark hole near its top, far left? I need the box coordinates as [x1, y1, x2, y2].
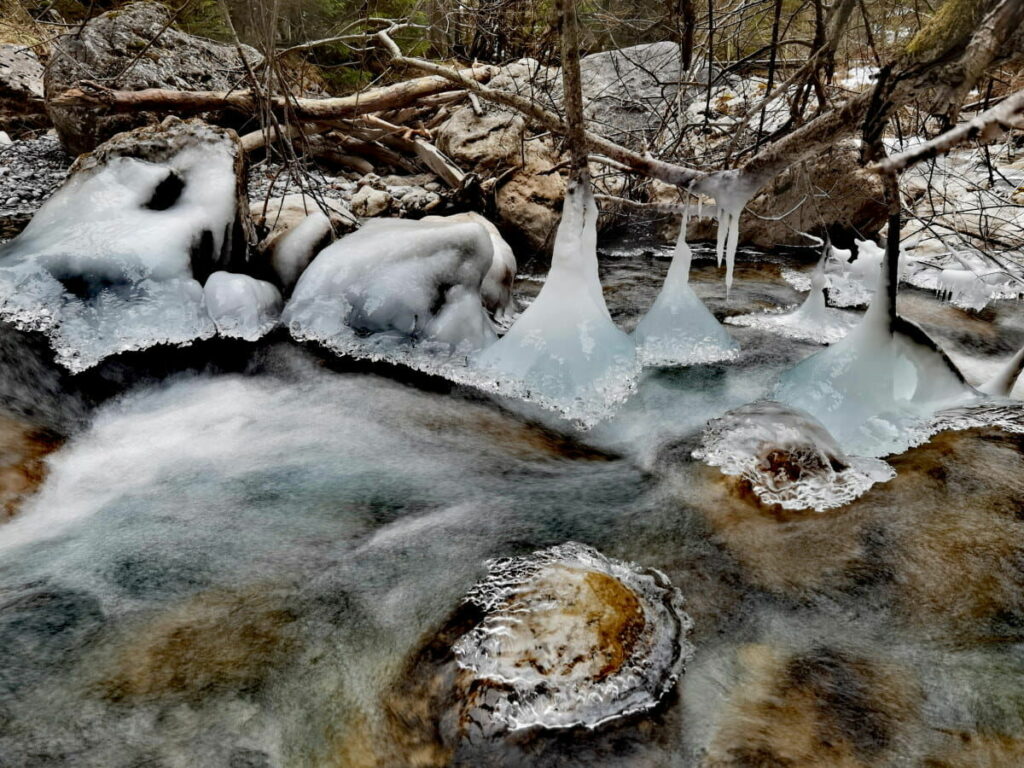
[0, 122, 237, 372]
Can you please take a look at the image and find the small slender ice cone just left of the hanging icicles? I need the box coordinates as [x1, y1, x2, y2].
[633, 205, 739, 366]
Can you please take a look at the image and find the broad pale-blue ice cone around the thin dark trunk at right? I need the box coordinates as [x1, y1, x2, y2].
[775, 243, 978, 457]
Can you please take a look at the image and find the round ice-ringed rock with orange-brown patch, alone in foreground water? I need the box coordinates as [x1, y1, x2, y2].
[454, 543, 693, 733]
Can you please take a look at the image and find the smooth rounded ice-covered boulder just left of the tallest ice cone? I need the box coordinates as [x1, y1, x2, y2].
[283, 219, 496, 362]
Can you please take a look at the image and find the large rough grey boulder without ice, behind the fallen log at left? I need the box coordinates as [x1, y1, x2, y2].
[45, 2, 262, 154]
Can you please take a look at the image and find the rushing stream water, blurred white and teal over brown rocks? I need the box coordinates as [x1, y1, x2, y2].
[0, 243, 1024, 768]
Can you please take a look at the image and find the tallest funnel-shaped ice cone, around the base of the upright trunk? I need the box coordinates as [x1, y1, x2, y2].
[476, 185, 639, 426]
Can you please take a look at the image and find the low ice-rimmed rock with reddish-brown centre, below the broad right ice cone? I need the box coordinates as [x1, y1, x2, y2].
[693, 400, 896, 512]
